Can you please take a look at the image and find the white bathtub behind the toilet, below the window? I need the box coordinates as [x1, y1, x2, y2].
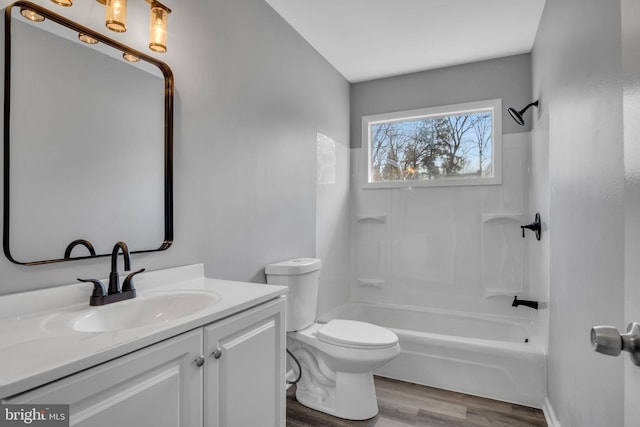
[318, 303, 546, 408]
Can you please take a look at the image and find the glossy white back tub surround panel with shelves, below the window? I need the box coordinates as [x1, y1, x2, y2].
[348, 132, 546, 318]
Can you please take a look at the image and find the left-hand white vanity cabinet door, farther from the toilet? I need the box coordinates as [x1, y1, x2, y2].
[7, 329, 202, 427]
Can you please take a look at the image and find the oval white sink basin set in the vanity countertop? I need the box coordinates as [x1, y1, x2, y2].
[48, 290, 220, 332]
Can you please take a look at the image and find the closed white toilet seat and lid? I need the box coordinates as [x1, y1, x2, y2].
[316, 319, 398, 350]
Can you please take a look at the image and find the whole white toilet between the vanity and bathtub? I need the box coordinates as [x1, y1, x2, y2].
[265, 258, 400, 420]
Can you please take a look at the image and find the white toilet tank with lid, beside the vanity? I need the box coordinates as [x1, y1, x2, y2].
[264, 258, 320, 331]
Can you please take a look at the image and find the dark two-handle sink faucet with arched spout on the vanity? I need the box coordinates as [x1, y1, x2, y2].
[78, 242, 145, 305]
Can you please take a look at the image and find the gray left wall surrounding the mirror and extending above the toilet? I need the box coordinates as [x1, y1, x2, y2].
[0, 0, 349, 296]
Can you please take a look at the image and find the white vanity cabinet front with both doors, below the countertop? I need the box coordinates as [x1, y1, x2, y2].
[3, 298, 285, 427]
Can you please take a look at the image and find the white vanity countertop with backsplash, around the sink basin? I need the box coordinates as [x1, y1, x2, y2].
[0, 264, 287, 399]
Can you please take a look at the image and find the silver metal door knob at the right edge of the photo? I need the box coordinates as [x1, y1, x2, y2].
[591, 323, 640, 366]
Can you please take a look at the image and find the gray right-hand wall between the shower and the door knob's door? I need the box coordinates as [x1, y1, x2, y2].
[532, 0, 624, 427]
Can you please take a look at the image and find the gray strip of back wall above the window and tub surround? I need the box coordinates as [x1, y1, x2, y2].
[351, 54, 532, 148]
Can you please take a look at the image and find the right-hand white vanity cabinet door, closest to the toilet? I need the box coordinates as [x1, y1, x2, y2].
[204, 298, 285, 427]
